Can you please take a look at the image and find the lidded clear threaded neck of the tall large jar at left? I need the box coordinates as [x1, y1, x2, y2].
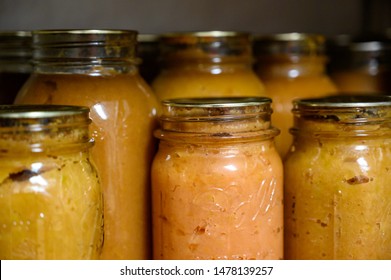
[32, 30, 138, 76]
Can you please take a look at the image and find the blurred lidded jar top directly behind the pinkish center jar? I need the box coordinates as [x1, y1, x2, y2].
[152, 31, 265, 100]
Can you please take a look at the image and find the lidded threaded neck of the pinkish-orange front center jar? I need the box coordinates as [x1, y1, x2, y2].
[155, 97, 279, 141]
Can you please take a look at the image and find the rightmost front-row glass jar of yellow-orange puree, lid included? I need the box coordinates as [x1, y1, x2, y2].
[284, 95, 391, 259]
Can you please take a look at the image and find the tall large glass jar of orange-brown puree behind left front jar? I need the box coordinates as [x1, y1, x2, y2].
[15, 30, 158, 259]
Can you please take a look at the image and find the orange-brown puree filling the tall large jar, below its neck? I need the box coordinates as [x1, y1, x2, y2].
[16, 71, 157, 259]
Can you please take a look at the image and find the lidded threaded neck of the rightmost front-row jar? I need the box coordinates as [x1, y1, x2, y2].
[291, 93, 391, 137]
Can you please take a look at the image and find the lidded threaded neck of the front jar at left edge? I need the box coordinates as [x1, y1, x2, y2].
[0, 105, 93, 155]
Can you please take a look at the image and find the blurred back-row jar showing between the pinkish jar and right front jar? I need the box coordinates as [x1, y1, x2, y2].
[253, 33, 337, 158]
